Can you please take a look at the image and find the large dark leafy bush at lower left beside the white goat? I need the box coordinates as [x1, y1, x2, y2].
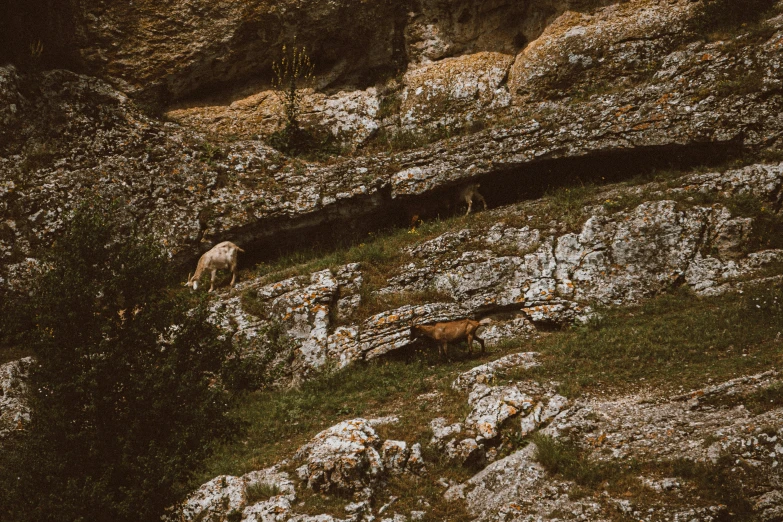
[0, 201, 236, 522]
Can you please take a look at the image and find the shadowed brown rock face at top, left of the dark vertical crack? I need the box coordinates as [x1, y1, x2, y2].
[71, 0, 404, 103]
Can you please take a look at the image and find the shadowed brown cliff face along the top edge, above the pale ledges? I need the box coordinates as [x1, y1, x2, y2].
[15, 0, 608, 103]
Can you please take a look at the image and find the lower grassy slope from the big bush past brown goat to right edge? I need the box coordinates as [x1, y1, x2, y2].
[195, 285, 783, 520]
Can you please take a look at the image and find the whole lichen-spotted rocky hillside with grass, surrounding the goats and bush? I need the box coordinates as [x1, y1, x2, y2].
[0, 0, 783, 522]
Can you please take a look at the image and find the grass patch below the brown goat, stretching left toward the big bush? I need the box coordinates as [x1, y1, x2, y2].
[193, 345, 498, 487]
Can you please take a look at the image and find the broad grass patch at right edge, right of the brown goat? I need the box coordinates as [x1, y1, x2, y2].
[524, 284, 783, 397]
